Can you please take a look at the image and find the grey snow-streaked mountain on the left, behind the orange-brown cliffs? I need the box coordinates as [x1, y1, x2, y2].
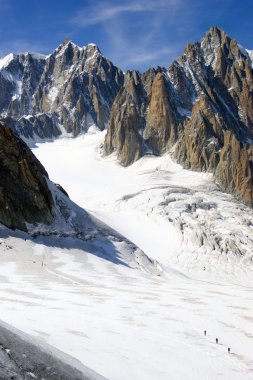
[0, 40, 124, 140]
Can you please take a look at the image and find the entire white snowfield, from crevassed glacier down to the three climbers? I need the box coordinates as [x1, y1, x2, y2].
[0, 128, 253, 380]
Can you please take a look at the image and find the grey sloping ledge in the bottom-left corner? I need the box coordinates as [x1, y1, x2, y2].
[0, 322, 106, 380]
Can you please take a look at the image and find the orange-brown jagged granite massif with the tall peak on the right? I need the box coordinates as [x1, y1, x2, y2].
[104, 27, 253, 205]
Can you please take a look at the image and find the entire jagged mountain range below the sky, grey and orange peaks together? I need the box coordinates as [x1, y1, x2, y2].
[0, 27, 253, 206]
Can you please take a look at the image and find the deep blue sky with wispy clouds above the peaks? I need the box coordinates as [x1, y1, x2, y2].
[0, 0, 253, 71]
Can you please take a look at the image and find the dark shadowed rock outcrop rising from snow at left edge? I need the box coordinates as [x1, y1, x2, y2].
[0, 123, 53, 231]
